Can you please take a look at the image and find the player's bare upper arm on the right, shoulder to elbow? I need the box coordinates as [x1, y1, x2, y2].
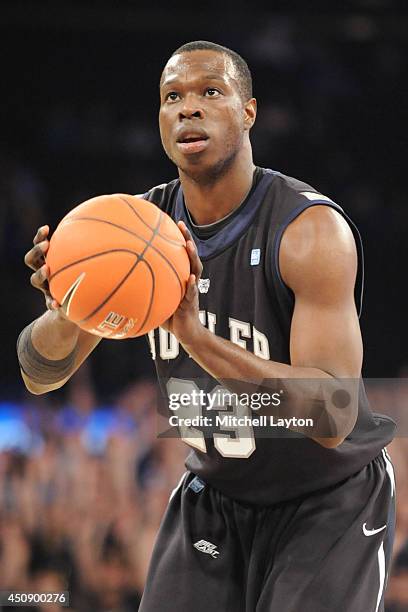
[279, 206, 363, 378]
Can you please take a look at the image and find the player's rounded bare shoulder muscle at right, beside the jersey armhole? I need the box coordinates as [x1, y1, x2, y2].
[279, 205, 357, 298]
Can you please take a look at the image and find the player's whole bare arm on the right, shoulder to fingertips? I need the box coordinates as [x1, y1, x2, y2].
[169, 206, 362, 448]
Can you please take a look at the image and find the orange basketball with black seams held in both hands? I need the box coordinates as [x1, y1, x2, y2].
[47, 193, 190, 339]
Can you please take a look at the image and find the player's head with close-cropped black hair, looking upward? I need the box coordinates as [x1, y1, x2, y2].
[159, 41, 256, 183]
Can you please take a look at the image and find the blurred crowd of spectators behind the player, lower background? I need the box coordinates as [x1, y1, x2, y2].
[0, 376, 408, 612]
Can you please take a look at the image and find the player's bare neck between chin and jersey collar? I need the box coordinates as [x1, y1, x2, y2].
[179, 141, 255, 225]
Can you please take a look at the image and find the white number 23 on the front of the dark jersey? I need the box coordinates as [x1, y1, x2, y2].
[166, 378, 255, 459]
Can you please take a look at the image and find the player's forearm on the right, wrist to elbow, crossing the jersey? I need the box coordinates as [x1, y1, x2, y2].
[183, 327, 358, 447]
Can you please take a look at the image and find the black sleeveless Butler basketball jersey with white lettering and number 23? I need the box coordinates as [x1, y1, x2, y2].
[143, 168, 395, 505]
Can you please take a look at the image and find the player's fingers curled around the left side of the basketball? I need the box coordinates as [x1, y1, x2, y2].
[24, 225, 61, 312]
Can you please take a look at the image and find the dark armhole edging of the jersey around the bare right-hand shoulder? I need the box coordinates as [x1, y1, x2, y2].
[272, 198, 364, 318]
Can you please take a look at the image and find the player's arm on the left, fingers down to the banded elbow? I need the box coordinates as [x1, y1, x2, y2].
[18, 226, 101, 395]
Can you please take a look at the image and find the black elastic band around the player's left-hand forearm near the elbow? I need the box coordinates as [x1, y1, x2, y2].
[17, 321, 78, 385]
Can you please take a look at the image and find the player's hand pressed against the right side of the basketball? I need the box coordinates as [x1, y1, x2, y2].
[162, 221, 203, 345]
